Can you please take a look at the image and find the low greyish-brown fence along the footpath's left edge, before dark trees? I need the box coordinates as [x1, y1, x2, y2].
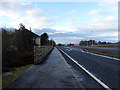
[34, 46, 53, 64]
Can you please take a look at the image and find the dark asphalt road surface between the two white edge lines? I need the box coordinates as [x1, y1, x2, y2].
[58, 47, 120, 88]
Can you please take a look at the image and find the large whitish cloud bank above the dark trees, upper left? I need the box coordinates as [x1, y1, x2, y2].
[0, 2, 54, 29]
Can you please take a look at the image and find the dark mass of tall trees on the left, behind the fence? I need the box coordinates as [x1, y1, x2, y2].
[1, 24, 56, 67]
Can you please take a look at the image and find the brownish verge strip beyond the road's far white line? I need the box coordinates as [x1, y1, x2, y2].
[82, 48, 120, 58]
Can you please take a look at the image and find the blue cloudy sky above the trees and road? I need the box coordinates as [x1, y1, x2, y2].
[0, 0, 118, 44]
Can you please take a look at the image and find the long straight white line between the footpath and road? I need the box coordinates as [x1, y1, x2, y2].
[59, 48, 112, 90]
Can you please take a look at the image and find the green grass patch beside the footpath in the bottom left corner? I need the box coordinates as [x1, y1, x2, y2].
[2, 64, 32, 88]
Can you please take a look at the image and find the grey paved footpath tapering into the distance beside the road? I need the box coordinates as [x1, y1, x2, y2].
[8, 48, 82, 88]
